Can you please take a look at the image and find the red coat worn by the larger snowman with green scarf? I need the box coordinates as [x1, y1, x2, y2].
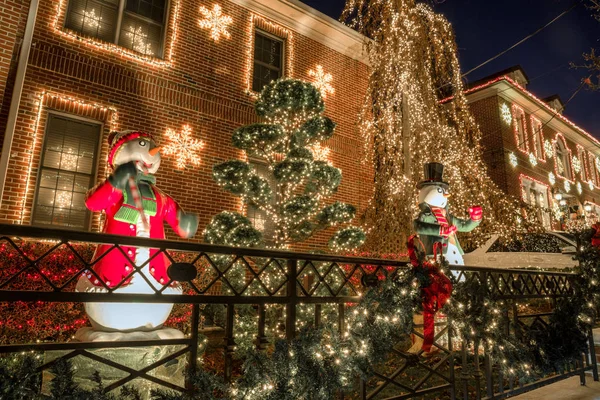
[85, 181, 185, 287]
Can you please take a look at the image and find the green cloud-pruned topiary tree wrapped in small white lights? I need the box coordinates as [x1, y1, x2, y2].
[204, 79, 365, 250]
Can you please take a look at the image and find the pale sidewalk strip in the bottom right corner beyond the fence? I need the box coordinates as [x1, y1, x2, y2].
[511, 375, 600, 400]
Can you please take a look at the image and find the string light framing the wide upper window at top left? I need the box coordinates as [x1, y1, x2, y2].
[51, 0, 181, 67]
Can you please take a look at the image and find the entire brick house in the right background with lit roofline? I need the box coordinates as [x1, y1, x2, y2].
[467, 66, 600, 229]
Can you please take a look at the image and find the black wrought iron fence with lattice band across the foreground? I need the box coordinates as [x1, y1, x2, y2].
[0, 225, 598, 399]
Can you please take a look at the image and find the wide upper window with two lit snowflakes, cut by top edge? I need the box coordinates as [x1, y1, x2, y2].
[65, 0, 168, 57]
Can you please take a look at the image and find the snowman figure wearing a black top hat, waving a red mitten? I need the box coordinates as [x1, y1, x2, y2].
[414, 163, 483, 274]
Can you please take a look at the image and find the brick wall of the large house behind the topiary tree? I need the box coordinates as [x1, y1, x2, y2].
[0, 0, 372, 250]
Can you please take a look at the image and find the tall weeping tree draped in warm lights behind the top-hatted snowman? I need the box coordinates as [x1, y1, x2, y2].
[342, 0, 532, 252]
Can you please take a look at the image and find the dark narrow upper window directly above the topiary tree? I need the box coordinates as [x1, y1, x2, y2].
[252, 30, 284, 92]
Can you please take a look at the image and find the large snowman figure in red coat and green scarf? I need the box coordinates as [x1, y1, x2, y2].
[76, 131, 198, 332]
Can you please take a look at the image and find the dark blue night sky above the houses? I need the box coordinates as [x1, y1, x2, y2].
[302, 0, 600, 139]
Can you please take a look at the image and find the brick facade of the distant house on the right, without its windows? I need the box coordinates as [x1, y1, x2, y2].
[468, 72, 600, 229]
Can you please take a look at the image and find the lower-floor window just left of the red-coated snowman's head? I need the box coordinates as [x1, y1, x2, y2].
[32, 114, 101, 229]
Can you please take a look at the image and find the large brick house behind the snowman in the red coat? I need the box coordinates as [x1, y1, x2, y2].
[0, 0, 372, 247]
